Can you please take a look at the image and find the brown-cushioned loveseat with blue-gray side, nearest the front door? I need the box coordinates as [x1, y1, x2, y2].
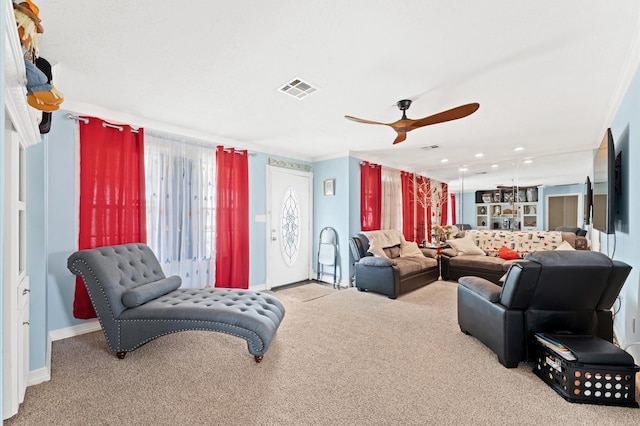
[349, 230, 440, 299]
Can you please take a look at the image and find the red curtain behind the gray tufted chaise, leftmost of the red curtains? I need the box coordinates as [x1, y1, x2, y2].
[73, 117, 147, 319]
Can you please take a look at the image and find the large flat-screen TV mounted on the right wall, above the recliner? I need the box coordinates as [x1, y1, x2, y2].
[591, 129, 616, 234]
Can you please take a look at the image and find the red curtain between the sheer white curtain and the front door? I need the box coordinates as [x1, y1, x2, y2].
[215, 146, 249, 289]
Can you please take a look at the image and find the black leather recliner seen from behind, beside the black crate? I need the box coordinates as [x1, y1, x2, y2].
[458, 250, 631, 368]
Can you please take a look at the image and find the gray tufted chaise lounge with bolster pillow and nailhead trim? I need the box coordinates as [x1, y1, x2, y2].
[67, 243, 284, 362]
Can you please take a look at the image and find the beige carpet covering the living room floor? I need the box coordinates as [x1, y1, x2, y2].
[5, 282, 640, 425]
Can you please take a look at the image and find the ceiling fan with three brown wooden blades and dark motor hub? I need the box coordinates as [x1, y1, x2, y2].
[345, 99, 480, 145]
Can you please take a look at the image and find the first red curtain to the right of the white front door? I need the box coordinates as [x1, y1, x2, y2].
[360, 161, 382, 231]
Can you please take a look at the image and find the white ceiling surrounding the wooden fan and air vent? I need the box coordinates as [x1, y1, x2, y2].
[36, 0, 640, 190]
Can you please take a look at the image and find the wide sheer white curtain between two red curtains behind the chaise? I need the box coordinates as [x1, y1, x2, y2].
[144, 130, 216, 288]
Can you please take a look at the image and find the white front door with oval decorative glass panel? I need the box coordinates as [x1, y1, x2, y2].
[267, 166, 313, 289]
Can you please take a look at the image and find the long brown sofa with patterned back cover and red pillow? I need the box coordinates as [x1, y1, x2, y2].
[440, 229, 589, 285]
